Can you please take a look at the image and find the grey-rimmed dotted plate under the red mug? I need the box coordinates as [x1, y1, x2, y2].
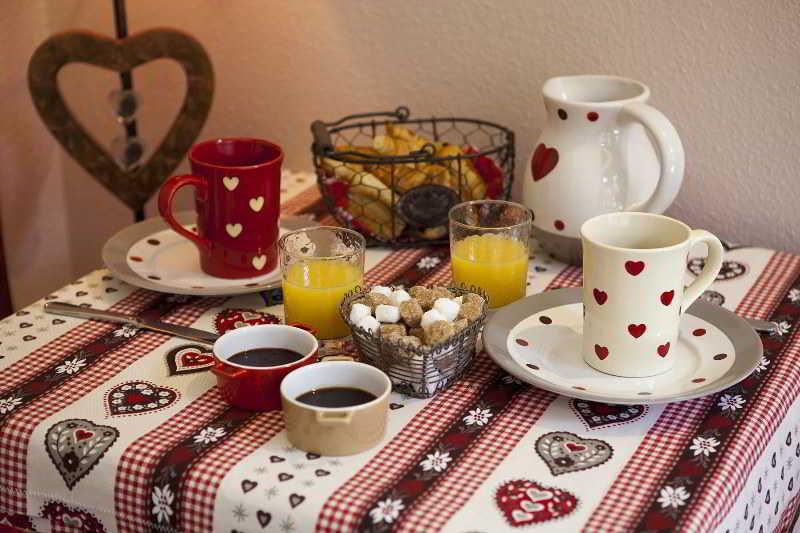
[103, 211, 281, 296]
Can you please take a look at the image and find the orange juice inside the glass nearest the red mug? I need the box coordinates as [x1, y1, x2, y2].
[283, 259, 362, 339]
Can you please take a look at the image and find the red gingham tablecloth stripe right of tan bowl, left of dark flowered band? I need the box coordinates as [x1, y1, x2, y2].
[316, 355, 499, 532]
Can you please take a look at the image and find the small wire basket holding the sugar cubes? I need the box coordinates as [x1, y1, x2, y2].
[339, 287, 486, 398]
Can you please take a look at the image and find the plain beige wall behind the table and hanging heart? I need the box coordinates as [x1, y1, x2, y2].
[0, 0, 800, 306]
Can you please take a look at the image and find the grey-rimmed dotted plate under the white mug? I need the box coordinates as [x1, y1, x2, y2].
[483, 289, 762, 404]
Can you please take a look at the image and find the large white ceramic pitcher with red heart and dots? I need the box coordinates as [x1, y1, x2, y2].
[523, 75, 684, 265]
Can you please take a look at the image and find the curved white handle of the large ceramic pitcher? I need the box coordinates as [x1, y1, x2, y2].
[619, 102, 685, 213]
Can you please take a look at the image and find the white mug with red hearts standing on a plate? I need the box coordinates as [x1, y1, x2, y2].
[581, 212, 724, 377]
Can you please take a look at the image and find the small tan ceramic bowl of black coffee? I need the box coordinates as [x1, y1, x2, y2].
[281, 361, 392, 455]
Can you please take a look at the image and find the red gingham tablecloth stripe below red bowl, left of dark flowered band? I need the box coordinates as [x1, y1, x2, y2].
[114, 387, 228, 533]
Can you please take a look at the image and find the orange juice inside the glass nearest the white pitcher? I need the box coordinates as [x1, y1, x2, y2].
[450, 233, 528, 307]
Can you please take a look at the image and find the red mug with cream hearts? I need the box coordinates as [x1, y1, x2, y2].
[158, 138, 283, 279]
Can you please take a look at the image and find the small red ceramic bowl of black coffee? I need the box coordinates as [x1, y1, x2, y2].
[211, 324, 319, 411]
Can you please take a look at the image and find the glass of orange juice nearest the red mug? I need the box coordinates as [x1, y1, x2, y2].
[278, 226, 366, 339]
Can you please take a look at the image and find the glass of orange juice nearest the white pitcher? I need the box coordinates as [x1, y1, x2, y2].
[450, 200, 533, 308]
